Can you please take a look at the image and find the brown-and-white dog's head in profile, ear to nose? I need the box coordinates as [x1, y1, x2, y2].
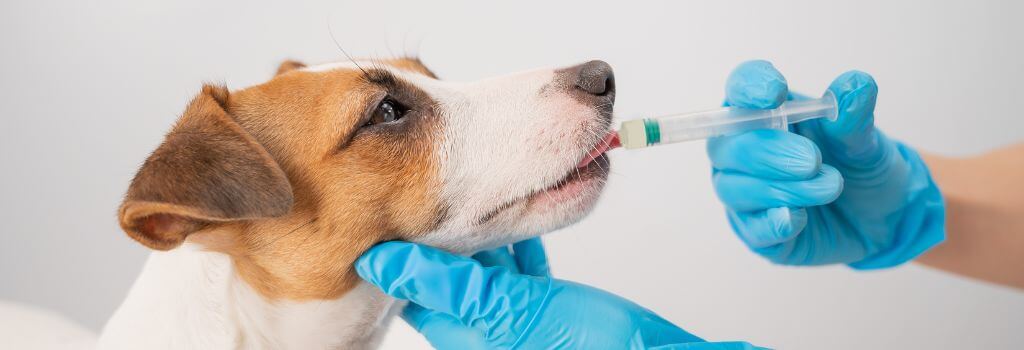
[119, 59, 615, 299]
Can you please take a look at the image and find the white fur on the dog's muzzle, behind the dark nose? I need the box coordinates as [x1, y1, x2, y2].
[398, 70, 606, 253]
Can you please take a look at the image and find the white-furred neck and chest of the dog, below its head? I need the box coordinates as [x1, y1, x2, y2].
[99, 244, 393, 349]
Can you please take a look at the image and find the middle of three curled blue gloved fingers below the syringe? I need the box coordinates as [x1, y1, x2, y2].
[713, 164, 843, 212]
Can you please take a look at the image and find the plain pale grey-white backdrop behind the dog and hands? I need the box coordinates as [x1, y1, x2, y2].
[0, 0, 1024, 349]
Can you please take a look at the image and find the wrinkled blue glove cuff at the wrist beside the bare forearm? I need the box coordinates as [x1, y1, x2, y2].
[849, 141, 946, 270]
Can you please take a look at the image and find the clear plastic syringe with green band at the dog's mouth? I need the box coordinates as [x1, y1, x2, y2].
[618, 91, 839, 149]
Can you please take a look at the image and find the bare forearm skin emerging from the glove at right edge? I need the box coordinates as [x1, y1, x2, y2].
[916, 143, 1024, 289]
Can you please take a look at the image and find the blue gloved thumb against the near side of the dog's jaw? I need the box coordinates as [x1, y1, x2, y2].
[355, 242, 547, 326]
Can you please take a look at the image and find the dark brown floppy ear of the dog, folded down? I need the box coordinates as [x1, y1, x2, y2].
[119, 85, 293, 250]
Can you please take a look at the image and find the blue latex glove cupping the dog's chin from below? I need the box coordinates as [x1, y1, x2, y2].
[355, 238, 754, 350]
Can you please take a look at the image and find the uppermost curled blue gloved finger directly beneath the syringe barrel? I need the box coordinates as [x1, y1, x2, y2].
[707, 129, 821, 180]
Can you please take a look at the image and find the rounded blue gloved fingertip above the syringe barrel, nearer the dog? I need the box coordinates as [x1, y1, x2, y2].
[725, 60, 790, 110]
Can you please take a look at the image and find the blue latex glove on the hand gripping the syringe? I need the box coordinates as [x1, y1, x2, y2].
[708, 60, 945, 269]
